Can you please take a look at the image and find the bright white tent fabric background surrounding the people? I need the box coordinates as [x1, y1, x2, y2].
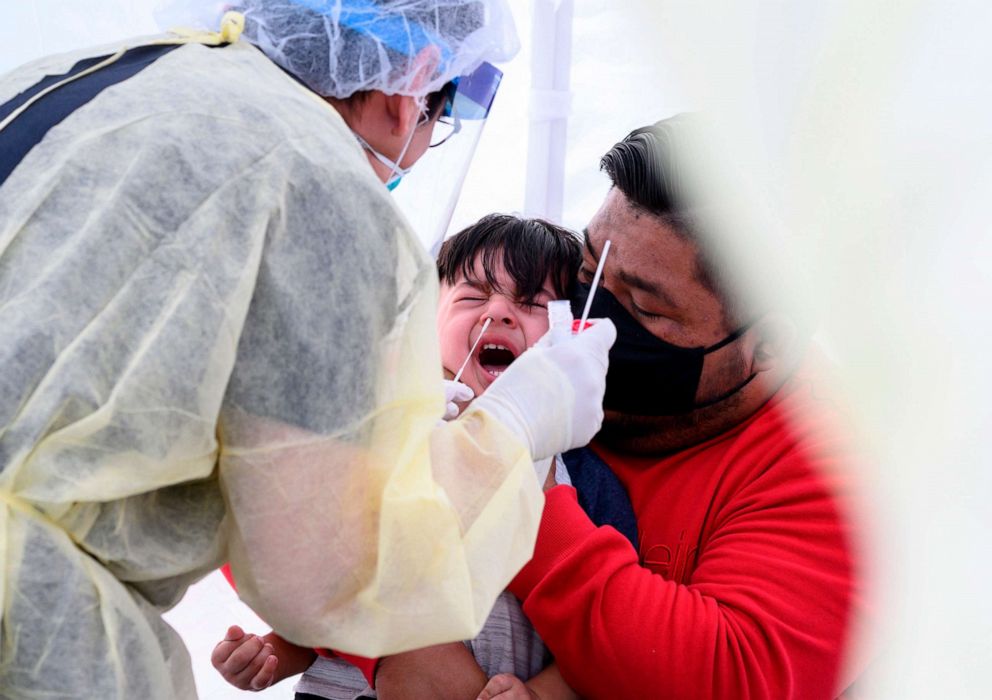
[0, 0, 992, 698]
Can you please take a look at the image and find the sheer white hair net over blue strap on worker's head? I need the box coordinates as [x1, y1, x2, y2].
[156, 0, 520, 98]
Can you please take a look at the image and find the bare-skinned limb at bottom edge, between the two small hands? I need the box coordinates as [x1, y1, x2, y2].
[375, 642, 486, 700]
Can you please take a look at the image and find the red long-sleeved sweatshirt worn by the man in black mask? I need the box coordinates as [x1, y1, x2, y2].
[510, 366, 856, 700]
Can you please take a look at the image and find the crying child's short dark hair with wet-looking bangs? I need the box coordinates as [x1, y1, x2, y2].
[437, 214, 582, 303]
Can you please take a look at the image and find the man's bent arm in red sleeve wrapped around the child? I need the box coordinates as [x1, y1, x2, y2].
[511, 456, 852, 698]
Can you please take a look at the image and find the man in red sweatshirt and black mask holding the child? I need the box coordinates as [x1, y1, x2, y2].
[484, 116, 863, 699]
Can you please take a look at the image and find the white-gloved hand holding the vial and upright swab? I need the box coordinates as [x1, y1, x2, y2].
[472, 319, 617, 461]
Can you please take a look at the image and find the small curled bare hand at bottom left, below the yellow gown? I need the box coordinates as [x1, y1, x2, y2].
[210, 625, 317, 690]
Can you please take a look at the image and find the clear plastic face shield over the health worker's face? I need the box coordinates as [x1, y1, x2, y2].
[393, 63, 503, 257]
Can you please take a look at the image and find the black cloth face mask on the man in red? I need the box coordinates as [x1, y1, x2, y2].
[571, 284, 757, 416]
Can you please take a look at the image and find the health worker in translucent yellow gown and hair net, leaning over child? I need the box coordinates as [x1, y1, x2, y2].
[0, 0, 614, 698]
